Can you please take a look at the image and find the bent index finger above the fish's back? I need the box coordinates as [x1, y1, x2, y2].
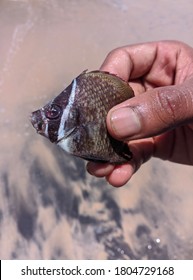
[101, 41, 180, 86]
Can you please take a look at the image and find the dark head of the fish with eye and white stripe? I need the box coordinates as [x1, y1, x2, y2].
[30, 81, 77, 143]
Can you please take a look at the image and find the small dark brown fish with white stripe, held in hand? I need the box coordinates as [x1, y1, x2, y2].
[30, 70, 134, 164]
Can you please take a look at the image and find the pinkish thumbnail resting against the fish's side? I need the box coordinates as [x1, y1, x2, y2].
[110, 107, 141, 138]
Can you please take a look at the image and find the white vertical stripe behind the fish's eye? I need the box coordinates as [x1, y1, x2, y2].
[57, 79, 77, 141]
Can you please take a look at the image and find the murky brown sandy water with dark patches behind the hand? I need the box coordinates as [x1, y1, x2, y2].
[0, 0, 193, 259]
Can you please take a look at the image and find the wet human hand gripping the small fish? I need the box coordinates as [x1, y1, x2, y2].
[87, 41, 193, 187]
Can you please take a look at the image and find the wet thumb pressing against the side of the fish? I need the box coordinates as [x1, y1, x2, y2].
[107, 80, 193, 140]
